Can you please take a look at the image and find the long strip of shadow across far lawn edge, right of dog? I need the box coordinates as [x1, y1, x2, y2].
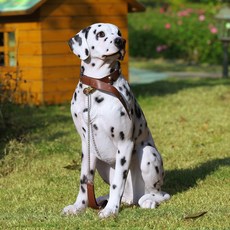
[131, 78, 230, 97]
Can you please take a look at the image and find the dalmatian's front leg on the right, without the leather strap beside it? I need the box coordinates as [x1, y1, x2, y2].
[99, 140, 133, 218]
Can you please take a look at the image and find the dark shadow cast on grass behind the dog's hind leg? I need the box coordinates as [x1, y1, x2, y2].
[163, 157, 230, 195]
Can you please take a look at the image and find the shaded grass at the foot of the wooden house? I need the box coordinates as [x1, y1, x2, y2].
[0, 104, 72, 160]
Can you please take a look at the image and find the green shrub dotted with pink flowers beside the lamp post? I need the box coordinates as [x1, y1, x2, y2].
[129, 4, 222, 64]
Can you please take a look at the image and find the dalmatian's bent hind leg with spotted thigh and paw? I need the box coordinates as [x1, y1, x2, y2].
[138, 146, 170, 208]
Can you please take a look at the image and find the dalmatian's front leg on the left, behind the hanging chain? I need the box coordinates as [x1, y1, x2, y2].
[63, 142, 96, 215]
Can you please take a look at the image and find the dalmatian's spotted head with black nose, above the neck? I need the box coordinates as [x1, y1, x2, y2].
[69, 23, 126, 60]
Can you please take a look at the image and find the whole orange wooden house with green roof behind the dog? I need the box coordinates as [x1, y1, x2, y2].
[0, 0, 144, 105]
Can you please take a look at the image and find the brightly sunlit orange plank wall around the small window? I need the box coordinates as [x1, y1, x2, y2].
[0, 20, 43, 104]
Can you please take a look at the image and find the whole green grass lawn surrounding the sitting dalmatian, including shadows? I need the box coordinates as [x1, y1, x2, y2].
[0, 78, 230, 230]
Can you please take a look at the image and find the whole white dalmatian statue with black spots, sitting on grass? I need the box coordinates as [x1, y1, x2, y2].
[63, 23, 170, 218]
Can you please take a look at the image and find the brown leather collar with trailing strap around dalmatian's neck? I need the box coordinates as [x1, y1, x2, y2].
[80, 70, 131, 119]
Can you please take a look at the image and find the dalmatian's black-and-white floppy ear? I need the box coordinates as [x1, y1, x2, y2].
[68, 27, 90, 60]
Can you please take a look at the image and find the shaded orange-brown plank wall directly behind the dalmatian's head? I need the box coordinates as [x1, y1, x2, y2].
[40, 0, 128, 103]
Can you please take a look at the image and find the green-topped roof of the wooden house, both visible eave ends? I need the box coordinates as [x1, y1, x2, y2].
[0, 0, 145, 16]
